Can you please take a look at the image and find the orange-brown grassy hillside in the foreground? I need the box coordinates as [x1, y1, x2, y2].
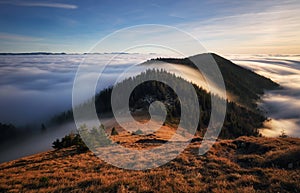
[0, 133, 300, 192]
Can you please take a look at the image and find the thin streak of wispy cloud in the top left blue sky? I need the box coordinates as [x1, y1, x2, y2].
[0, 1, 78, 9]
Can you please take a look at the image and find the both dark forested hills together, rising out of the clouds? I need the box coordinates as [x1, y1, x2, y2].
[53, 54, 278, 138]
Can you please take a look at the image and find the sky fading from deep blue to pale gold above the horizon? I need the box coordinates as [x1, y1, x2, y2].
[0, 0, 300, 54]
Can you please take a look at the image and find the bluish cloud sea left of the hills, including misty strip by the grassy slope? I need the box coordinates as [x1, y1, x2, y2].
[0, 54, 156, 163]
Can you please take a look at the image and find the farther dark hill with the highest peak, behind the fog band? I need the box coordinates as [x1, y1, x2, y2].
[144, 53, 279, 109]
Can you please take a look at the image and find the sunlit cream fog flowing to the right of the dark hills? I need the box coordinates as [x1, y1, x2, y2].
[228, 55, 300, 137]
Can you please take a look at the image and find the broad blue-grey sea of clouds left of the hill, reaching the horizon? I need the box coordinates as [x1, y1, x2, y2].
[0, 54, 159, 125]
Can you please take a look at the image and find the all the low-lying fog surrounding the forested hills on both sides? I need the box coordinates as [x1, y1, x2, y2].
[0, 54, 300, 162]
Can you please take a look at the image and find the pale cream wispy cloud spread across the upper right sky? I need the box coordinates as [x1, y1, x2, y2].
[178, 2, 300, 53]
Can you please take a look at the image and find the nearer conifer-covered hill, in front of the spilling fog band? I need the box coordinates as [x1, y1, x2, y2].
[54, 69, 266, 138]
